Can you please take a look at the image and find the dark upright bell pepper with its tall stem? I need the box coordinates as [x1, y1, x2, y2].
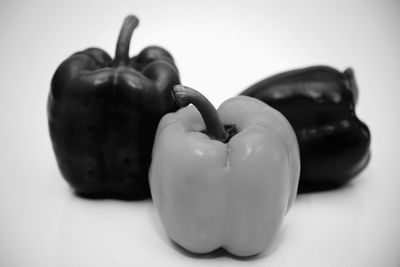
[48, 16, 180, 199]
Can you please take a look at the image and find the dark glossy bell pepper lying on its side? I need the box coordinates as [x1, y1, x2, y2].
[242, 66, 371, 190]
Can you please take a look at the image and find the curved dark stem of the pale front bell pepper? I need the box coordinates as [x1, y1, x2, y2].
[172, 85, 228, 143]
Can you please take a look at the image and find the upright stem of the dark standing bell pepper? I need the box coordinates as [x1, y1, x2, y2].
[114, 15, 139, 66]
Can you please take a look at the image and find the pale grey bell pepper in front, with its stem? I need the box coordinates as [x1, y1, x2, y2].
[149, 85, 300, 256]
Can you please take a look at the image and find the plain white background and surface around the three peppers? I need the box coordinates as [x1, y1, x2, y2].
[0, 0, 400, 267]
